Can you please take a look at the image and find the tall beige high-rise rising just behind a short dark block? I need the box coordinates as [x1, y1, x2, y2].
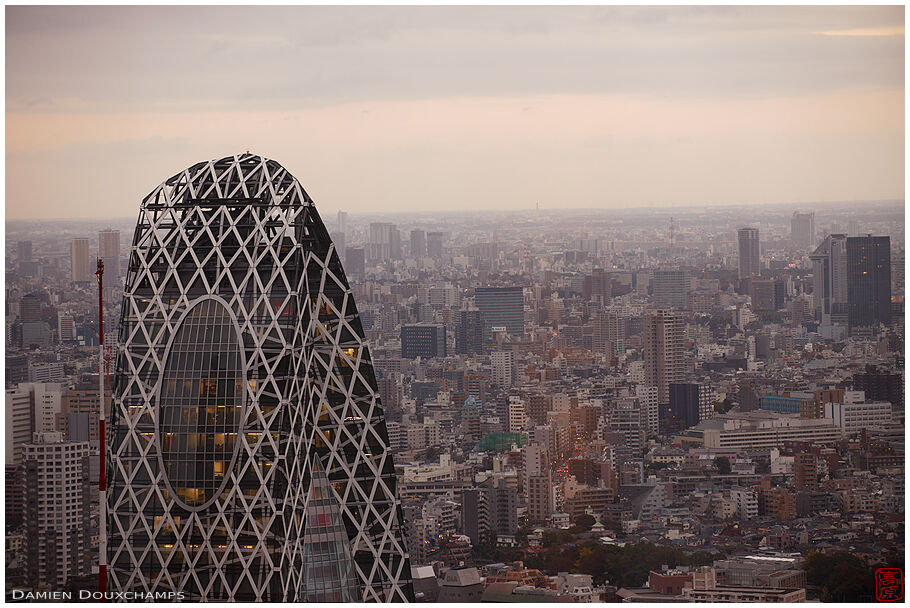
[642, 308, 685, 404]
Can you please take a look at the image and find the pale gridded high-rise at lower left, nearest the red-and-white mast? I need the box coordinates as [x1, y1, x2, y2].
[22, 432, 91, 589]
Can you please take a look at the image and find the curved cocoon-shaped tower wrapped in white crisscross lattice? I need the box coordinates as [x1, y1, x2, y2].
[106, 153, 413, 602]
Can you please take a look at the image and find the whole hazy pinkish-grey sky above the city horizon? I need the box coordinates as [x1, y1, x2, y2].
[6, 6, 904, 219]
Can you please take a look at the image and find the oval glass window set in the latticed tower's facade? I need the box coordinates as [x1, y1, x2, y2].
[158, 297, 246, 510]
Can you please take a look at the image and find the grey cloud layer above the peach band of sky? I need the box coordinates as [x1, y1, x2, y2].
[7, 6, 904, 112]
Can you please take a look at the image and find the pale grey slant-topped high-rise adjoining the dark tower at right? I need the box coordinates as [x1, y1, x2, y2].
[809, 234, 848, 325]
